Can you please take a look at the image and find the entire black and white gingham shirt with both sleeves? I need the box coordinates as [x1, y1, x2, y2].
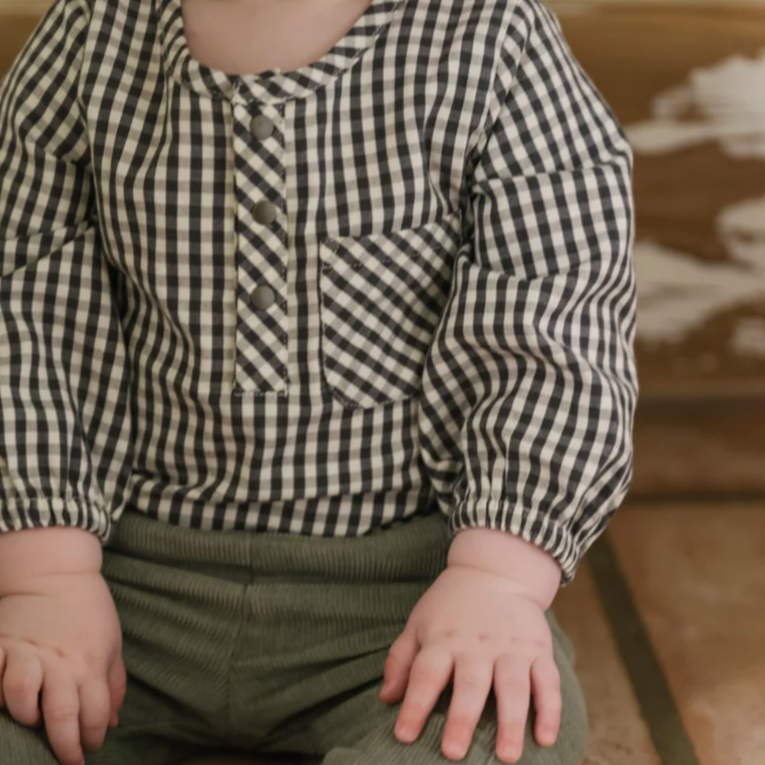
[0, 0, 637, 585]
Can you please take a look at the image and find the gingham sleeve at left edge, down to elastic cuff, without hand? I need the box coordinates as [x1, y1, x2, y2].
[0, 0, 131, 540]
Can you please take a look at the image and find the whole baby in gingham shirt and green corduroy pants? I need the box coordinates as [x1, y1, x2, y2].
[0, 0, 637, 765]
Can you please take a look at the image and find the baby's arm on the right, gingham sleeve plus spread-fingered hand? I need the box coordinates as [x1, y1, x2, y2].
[381, 0, 637, 762]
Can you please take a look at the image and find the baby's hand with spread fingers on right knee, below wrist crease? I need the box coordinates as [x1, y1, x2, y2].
[380, 566, 561, 762]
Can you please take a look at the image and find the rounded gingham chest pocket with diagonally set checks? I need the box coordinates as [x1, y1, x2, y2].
[319, 211, 461, 407]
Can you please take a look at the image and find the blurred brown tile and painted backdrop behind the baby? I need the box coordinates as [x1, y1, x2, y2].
[0, 0, 765, 765]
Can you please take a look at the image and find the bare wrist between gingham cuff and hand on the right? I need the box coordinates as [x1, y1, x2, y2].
[448, 528, 561, 611]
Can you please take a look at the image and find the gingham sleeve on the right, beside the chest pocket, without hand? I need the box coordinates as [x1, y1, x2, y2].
[414, 0, 637, 586]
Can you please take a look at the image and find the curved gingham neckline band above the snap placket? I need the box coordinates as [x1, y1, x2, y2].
[152, 0, 406, 103]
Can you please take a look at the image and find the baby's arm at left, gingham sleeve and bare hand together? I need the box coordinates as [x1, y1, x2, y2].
[0, 0, 131, 765]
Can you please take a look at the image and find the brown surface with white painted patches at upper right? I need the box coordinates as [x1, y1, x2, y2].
[552, 2, 765, 398]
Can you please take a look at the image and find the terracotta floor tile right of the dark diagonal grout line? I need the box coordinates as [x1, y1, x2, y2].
[609, 503, 765, 765]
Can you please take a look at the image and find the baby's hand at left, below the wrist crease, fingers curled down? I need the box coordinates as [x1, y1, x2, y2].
[0, 571, 126, 765]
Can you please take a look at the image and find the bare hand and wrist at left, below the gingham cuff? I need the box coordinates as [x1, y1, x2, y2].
[0, 528, 121, 765]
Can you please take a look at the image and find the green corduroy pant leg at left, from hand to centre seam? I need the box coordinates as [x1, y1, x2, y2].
[0, 508, 250, 765]
